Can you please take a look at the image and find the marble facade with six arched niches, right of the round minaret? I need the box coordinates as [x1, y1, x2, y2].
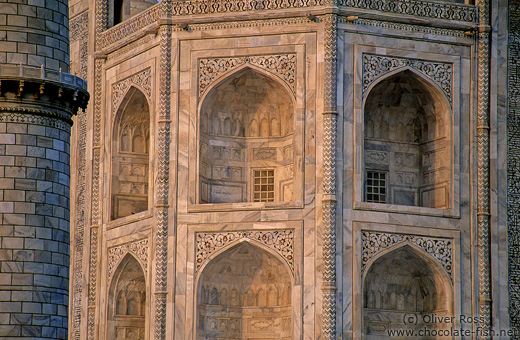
[70, 0, 507, 340]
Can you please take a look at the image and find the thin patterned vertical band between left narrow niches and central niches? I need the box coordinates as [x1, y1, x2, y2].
[154, 25, 172, 340]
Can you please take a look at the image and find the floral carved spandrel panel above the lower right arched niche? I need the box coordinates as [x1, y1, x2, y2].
[361, 231, 453, 279]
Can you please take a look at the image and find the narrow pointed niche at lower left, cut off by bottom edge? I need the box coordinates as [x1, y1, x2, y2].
[107, 254, 146, 340]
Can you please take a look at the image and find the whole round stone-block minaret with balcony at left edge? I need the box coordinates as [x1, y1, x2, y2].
[0, 0, 88, 339]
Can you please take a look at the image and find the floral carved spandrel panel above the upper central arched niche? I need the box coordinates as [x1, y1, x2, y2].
[199, 54, 296, 96]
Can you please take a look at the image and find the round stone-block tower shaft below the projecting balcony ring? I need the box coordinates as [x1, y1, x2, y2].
[0, 118, 70, 339]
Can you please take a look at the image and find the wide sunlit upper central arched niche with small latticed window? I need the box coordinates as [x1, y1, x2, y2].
[199, 68, 295, 203]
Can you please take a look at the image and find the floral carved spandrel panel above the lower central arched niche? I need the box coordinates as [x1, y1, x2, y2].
[195, 229, 294, 272]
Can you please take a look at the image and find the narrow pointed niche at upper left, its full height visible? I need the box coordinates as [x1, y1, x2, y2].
[111, 87, 150, 219]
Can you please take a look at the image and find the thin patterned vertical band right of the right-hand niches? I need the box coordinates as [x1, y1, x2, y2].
[476, 0, 492, 330]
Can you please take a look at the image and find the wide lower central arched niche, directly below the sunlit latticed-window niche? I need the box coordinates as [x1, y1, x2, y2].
[196, 242, 293, 340]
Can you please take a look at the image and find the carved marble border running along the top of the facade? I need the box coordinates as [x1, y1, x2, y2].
[92, 0, 477, 49]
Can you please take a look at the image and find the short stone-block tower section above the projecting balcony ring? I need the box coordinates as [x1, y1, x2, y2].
[0, 0, 69, 72]
